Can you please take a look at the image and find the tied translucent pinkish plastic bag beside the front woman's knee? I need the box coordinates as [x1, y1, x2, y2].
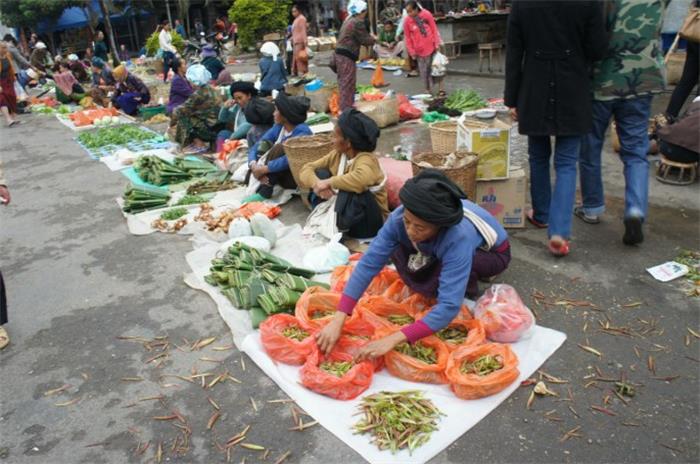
[474, 284, 535, 343]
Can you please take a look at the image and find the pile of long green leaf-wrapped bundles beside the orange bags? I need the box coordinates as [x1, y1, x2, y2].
[204, 243, 328, 327]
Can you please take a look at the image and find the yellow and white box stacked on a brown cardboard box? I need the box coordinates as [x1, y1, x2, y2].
[457, 119, 512, 180]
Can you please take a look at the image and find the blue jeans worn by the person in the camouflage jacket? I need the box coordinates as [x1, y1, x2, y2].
[579, 96, 651, 219]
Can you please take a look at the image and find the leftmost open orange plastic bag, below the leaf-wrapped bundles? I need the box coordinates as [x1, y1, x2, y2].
[260, 314, 317, 365]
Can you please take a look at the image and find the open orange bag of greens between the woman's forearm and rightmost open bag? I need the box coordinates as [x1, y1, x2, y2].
[374, 329, 450, 384]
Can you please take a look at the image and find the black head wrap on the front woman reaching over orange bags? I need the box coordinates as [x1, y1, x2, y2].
[399, 169, 467, 227]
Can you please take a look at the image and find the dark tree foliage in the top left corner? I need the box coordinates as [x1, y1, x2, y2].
[0, 0, 84, 27]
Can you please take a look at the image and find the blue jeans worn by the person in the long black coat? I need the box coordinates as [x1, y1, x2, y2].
[528, 135, 581, 239]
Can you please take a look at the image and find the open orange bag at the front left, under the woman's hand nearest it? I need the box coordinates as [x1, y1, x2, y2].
[299, 348, 374, 400]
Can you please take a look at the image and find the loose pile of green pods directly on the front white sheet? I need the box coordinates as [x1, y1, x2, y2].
[353, 391, 444, 454]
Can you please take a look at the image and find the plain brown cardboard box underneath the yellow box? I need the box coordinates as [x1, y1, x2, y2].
[476, 168, 527, 229]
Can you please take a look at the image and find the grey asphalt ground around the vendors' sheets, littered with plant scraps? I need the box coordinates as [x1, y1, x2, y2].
[0, 62, 700, 463]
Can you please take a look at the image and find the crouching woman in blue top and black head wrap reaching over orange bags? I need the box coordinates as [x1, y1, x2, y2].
[316, 169, 510, 359]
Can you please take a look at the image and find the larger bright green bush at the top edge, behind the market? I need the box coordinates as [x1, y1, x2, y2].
[228, 0, 292, 48]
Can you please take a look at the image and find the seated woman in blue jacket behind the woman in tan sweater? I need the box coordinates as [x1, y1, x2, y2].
[248, 93, 312, 198]
